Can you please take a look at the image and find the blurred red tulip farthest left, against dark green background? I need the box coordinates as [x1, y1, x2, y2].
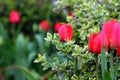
[9, 10, 20, 23]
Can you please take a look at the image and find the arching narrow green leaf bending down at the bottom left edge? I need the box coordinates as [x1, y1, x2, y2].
[18, 66, 37, 80]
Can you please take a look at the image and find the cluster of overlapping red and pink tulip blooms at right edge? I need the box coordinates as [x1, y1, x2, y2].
[88, 19, 120, 56]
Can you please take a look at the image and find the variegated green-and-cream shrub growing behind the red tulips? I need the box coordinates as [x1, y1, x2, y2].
[33, 0, 120, 80]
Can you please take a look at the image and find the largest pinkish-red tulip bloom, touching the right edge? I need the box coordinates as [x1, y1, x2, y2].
[101, 19, 120, 49]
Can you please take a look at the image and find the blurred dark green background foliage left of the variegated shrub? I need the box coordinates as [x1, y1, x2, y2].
[0, 0, 65, 80]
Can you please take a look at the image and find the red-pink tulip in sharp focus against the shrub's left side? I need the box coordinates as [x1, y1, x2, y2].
[58, 24, 73, 42]
